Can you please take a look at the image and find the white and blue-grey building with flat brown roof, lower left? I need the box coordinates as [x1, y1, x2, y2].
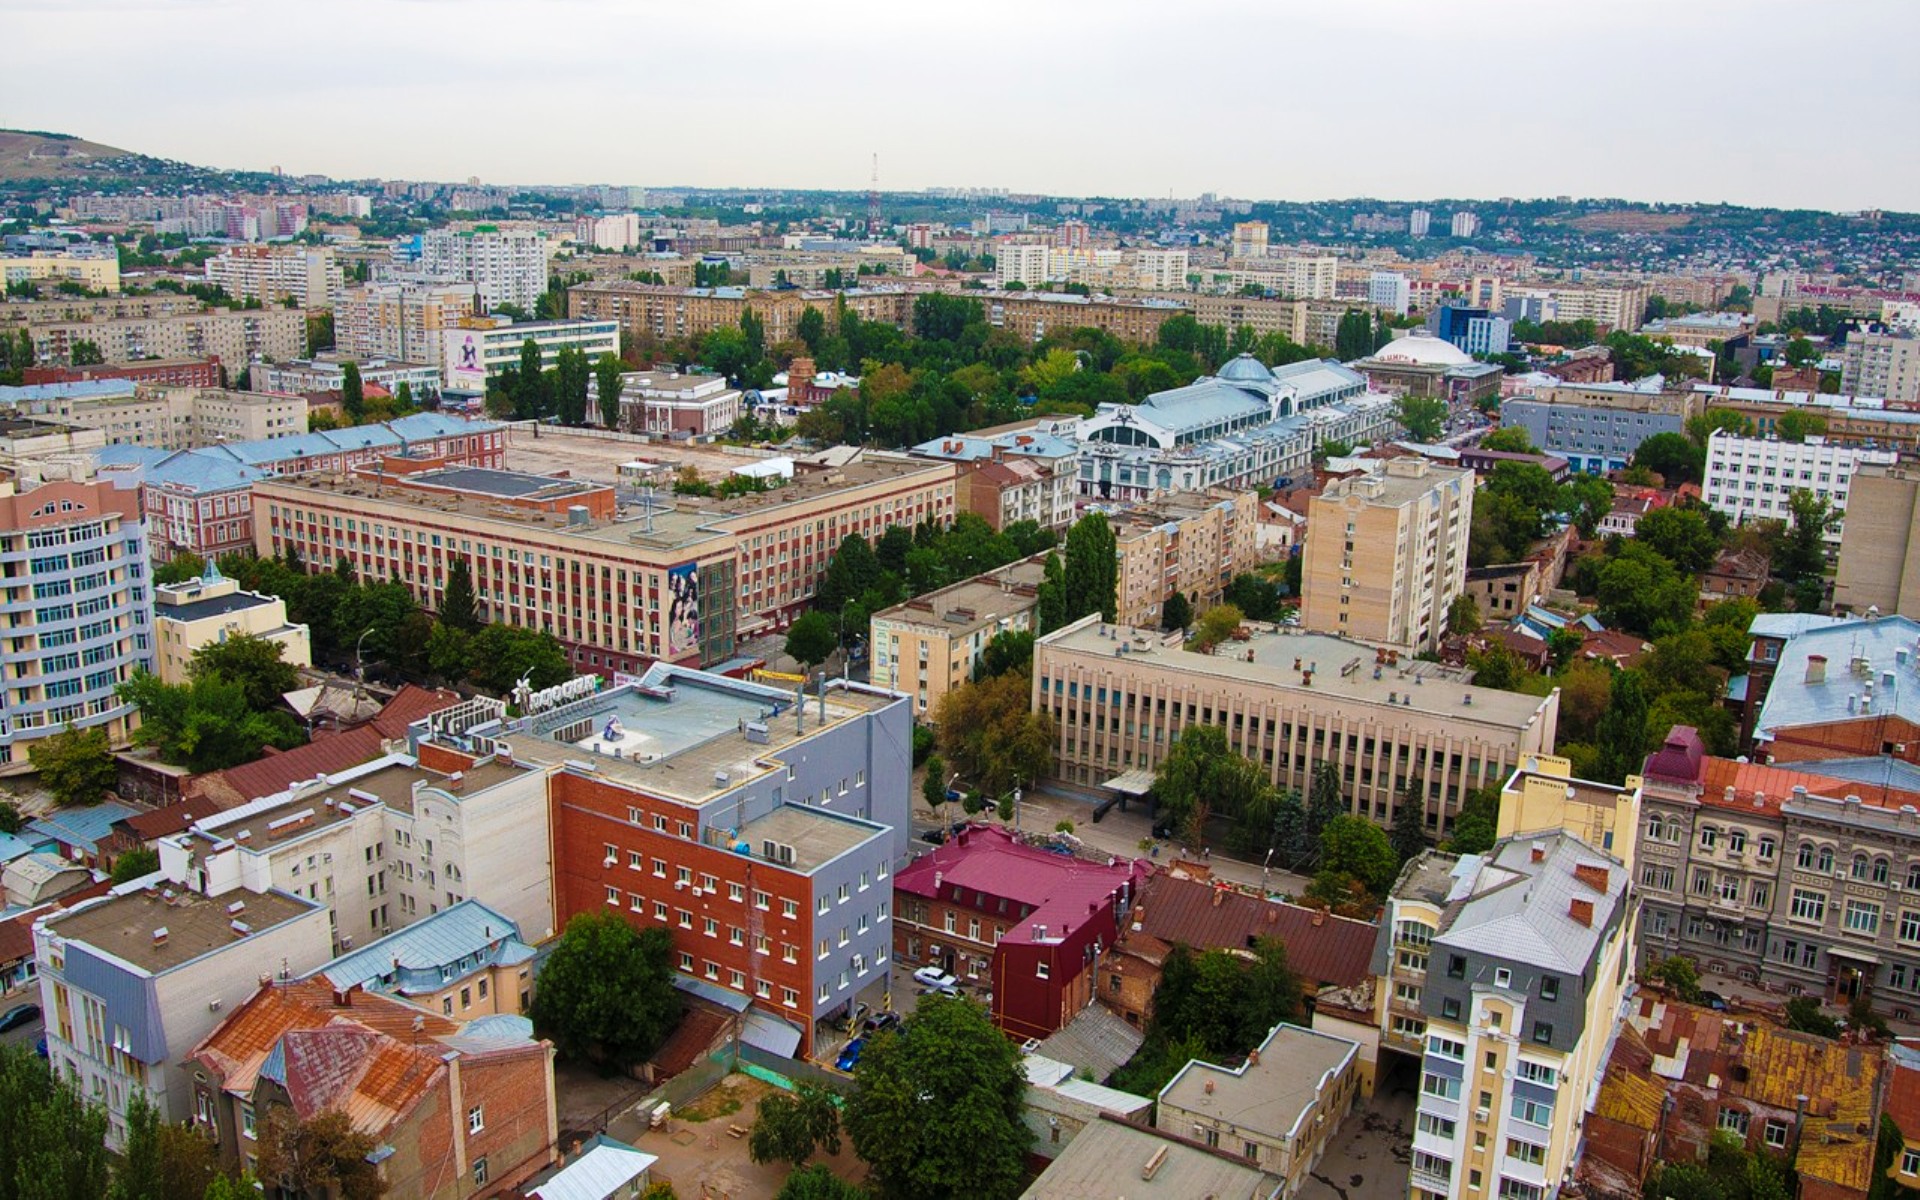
[33, 883, 332, 1148]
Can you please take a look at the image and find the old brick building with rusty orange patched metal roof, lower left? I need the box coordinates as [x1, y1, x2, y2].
[188, 979, 559, 1200]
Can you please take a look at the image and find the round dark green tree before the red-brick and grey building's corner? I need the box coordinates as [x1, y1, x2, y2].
[530, 912, 680, 1069]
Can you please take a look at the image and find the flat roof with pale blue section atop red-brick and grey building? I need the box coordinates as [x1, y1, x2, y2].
[505, 666, 897, 804]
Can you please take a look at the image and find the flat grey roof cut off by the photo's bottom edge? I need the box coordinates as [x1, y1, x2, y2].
[1021, 1117, 1284, 1200]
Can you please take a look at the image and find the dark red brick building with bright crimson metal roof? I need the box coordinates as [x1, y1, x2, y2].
[893, 826, 1152, 1039]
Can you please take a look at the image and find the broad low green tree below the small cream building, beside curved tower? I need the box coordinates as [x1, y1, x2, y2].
[115, 670, 303, 772]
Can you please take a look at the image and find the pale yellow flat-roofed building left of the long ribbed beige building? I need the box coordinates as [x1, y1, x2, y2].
[868, 559, 1044, 720]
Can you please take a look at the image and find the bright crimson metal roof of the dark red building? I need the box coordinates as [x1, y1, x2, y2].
[893, 826, 1152, 945]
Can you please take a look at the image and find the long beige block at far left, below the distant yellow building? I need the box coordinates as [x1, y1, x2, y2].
[27, 309, 307, 371]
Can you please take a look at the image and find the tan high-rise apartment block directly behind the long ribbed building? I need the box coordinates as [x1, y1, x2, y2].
[1300, 457, 1473, 651]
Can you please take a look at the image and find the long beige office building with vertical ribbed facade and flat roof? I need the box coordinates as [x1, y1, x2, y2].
[1033, 614, 1559, 837]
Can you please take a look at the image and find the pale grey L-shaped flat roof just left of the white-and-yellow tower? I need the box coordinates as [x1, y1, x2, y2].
[1160, 1023, 1359, 1139]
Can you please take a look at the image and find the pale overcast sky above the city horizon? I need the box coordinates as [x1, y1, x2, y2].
[0, 0, 1920, 211]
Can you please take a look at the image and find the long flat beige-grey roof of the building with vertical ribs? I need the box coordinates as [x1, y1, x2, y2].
[1039, 620, 1548, 730]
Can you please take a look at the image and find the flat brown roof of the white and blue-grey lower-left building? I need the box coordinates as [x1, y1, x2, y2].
[46, 887, 323, 975]
